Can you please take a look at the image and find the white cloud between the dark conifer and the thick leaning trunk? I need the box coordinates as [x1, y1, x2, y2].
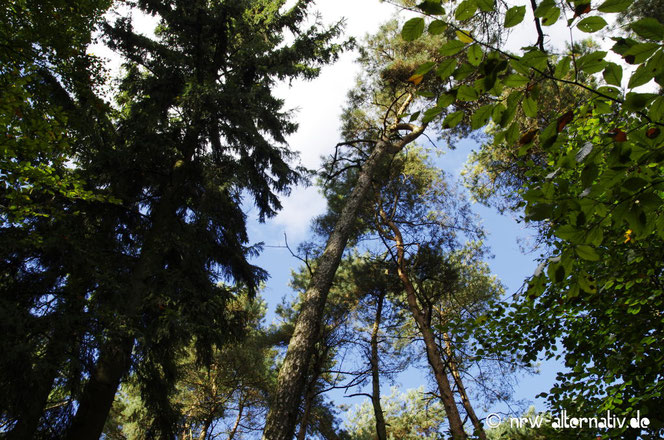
[260, 0, 396, 241]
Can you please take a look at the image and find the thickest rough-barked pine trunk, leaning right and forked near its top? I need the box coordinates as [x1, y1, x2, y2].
[263, 93, 426, 440]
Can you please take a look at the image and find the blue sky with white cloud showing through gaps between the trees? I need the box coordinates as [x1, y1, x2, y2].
[243, 0, 561, 415]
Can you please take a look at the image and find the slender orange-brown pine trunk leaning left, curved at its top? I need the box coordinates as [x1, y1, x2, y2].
[378, 205, 468, 440]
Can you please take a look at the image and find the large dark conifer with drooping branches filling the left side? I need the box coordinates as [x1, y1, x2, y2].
[3, 0, 343, 439]
